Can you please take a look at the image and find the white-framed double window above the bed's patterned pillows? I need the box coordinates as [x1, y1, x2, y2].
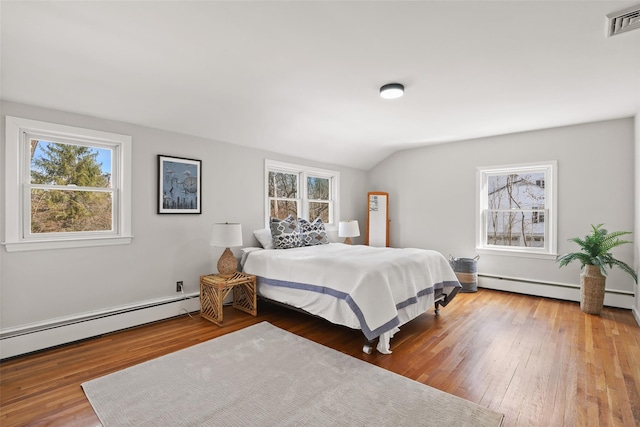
[265, 160, 340, 224]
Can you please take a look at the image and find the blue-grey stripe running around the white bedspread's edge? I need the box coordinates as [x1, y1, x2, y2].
[257, 276, 460, 340]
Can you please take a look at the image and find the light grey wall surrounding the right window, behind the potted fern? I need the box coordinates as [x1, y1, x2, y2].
[368, 118, 634, 308]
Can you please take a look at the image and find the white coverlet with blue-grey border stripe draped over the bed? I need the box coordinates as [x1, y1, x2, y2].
[244, 243, 460, 352]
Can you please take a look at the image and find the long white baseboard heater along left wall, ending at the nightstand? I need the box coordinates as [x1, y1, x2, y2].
[0, 293, 200, 359]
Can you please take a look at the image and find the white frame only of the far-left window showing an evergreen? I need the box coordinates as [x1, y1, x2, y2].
[2, 116, 133, 252]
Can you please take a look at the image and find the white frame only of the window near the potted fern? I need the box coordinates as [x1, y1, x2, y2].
[476, 160, 558, 259]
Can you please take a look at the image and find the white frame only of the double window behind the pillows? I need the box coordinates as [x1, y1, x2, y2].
[264, 159, 340, 228]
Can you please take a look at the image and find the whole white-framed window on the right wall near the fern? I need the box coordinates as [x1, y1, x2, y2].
[477, 162, 557, 258]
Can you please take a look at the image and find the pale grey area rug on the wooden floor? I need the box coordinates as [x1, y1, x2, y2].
[82, 322, 504, 427]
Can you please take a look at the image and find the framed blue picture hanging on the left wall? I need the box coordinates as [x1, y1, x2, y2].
[158, 154, 202, 214]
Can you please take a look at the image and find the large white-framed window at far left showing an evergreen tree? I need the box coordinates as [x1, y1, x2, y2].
[5, 116, 131, 252]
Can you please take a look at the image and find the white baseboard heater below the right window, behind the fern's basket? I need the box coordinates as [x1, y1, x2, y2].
[478, 273, 637, 310]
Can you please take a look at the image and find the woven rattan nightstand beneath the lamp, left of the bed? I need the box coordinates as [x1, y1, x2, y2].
[200, 271, 258, 326]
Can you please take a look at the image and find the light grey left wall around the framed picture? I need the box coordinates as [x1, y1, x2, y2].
[0, 102, 366, 332]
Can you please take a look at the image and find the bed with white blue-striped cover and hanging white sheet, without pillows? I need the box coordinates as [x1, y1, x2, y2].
[242, 243, 461, 354]
